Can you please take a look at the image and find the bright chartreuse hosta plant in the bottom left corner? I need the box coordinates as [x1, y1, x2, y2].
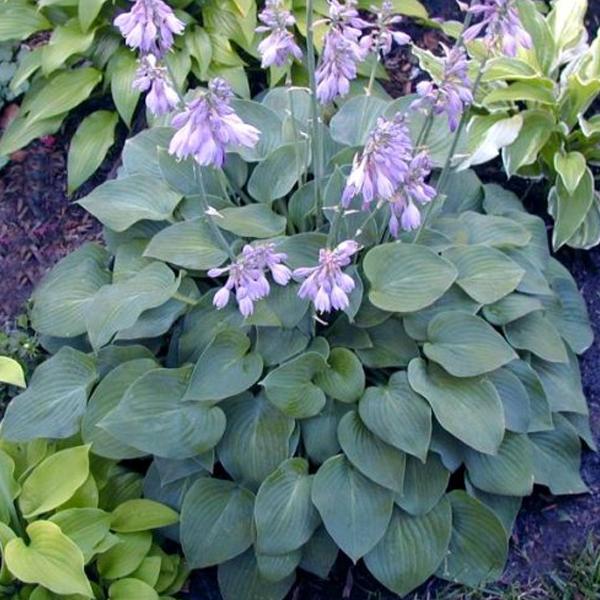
[0, 436, 188, 600]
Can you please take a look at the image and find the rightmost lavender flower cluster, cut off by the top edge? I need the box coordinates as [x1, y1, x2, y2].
[464, 0, 533, 56]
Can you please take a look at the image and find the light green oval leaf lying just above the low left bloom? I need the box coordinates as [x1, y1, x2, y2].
[214, 204, 286, 238]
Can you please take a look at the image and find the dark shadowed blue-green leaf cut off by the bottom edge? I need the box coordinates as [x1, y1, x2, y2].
[218, 549, 295, 600]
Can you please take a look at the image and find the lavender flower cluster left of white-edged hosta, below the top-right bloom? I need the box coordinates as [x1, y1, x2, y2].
[412, 45, 473, 131]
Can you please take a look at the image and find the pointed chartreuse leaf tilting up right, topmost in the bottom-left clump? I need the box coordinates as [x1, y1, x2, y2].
[19, 446, 90, 519]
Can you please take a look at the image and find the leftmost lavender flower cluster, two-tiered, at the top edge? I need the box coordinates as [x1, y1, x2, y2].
[114, 0, 185, 116]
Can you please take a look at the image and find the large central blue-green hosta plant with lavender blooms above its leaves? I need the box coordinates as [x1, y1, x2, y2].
[2, 61, 592, 600]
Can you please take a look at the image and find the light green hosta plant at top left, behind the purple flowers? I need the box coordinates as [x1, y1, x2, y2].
[0, 0, 427, 191]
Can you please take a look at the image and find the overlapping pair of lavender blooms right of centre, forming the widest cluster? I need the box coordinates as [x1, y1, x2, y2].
[342, 114, 436, 237]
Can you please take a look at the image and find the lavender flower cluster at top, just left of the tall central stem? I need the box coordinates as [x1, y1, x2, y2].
[256, 0, 302, 69]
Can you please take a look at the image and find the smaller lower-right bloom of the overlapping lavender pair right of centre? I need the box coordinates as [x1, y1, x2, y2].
[388, 152, 437, 237]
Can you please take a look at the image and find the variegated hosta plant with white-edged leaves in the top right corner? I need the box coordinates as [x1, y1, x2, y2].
[421, 0, 600, 249]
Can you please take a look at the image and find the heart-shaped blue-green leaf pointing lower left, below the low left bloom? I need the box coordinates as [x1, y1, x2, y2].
[183, 329, 263, 403]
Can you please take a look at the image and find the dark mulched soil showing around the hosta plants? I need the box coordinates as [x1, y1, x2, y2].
[0, 0, 600, 600]
